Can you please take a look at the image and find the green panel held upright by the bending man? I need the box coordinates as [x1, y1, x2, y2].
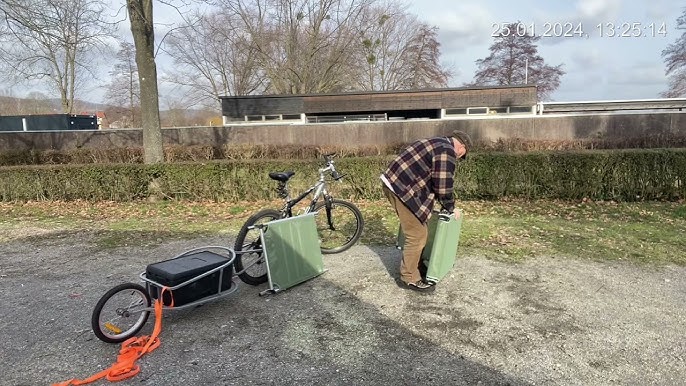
[396, 212, 462, 283]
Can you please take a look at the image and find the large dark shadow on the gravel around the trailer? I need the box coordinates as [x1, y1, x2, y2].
[0, 233, 525, 385]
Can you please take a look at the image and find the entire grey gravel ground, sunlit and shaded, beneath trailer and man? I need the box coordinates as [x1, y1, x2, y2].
[0, 228, 686, 385]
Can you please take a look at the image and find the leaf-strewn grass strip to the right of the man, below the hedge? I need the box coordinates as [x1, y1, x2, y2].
[461, 201, 686, 264]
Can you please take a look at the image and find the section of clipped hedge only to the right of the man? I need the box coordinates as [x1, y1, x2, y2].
[456, 149, 686, 201]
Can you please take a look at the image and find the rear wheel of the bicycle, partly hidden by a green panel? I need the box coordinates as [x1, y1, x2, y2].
[233, 209, 281, 285]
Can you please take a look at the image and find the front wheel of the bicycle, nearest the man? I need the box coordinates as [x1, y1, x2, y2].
[314, 198, 364, 254]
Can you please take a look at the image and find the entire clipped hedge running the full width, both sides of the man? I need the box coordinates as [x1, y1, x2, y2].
[0, 149, 686, 201]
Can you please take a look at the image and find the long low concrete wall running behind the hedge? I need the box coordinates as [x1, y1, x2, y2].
[0, 112, 686, 150]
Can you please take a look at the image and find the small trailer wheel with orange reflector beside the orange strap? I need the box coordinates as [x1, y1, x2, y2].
[91, 283, 150, 343]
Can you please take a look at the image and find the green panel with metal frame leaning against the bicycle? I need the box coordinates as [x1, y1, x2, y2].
[262, 213, 324, 290]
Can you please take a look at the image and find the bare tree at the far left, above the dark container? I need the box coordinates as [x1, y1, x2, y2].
[0, 0, 113, 113]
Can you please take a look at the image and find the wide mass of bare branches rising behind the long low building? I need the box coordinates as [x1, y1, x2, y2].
[185, 0, 450, 95]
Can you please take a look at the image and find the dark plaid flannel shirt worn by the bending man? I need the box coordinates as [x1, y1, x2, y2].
[383, 137, 457, 223]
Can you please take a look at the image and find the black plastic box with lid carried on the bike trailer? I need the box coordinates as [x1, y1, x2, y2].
[145, 251, 233, 307]
